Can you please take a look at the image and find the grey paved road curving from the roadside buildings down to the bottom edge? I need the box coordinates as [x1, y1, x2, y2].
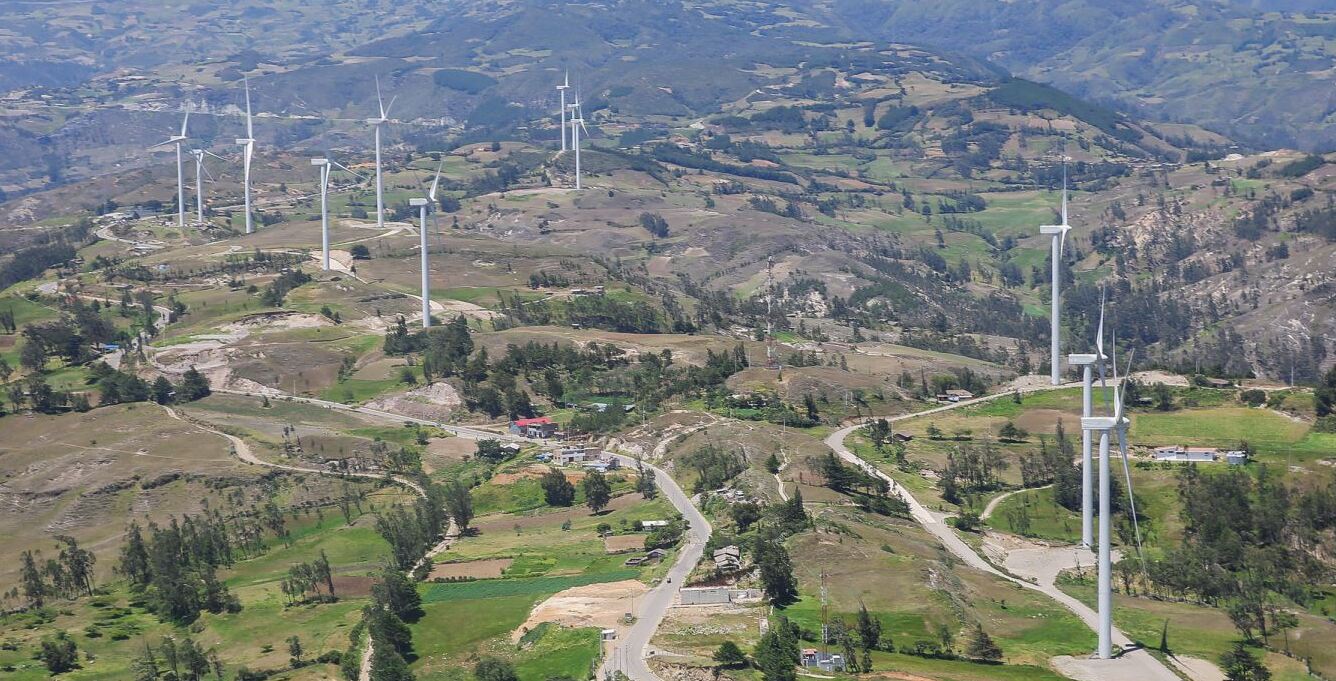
[599, 454, 712, 681]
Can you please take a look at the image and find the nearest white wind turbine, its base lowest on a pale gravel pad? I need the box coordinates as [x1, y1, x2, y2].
[1081, 331, 1141, 660]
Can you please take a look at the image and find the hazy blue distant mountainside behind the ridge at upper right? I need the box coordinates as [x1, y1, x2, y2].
[796, 0, 1336, 150]
